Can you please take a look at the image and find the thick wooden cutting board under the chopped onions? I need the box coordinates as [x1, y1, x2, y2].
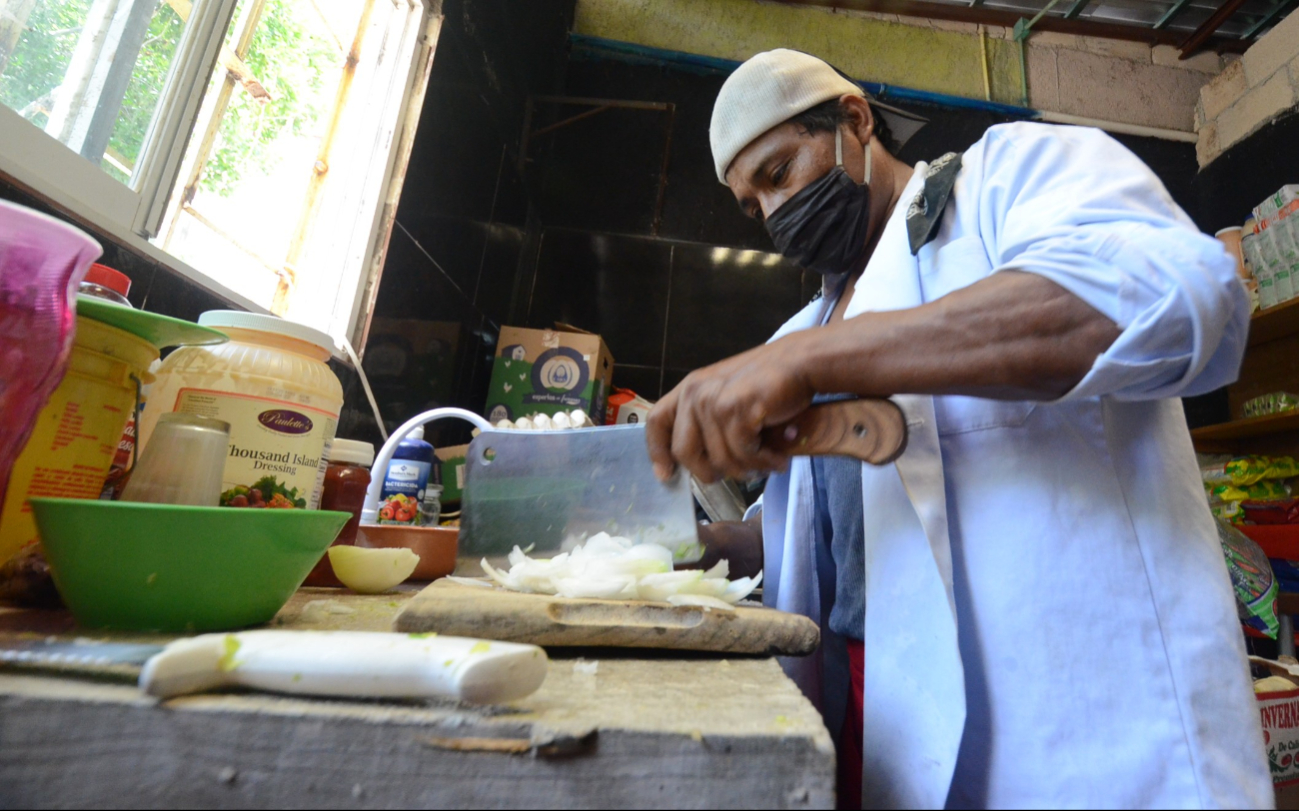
[392, 580, 821, 656]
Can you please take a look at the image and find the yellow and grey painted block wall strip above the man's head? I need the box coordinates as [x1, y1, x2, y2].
[574, 0, 1226, 134]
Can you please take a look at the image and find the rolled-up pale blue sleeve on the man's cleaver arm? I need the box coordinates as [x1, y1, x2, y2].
[968, 123, 1250, 400]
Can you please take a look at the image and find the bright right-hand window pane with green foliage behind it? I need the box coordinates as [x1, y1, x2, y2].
[162, 0, 373, 309]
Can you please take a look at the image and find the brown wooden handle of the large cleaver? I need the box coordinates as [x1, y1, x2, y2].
[764, 398, 907, 465]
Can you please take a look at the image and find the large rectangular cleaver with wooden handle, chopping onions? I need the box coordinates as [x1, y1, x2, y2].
[460, 399, 907, 564]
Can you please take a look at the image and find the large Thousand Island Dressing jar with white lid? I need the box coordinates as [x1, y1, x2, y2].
[140, 311, 343, 509]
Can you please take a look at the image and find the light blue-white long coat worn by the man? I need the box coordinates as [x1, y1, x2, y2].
[763, 122, 1273, 808]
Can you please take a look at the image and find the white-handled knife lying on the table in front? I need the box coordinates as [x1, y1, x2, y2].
[0, 630, 548, 704]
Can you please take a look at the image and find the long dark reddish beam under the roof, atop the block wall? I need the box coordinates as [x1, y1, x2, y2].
[774, 0, 1252, 53]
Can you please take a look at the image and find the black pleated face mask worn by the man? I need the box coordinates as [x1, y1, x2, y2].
[766, 130, 870, 276]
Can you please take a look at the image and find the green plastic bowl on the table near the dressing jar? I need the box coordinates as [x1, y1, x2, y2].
[31, 498, 351, 633]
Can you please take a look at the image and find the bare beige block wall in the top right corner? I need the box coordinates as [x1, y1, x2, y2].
[1195, 13, 1299, 169]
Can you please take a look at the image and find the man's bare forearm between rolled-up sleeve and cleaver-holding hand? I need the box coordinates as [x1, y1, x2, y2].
[782, 272, 1120, 400]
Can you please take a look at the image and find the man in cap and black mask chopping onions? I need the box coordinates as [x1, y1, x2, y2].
[648, 51, 1273, 808]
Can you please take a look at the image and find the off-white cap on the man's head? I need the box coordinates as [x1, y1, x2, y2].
[708, 48, 866, 185]
